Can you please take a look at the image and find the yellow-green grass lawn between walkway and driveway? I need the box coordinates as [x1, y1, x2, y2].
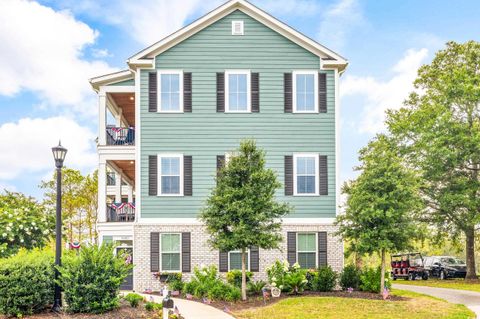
[234, 290, 475, 319]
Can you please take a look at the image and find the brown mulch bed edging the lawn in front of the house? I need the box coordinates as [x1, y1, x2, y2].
[154, 291, 410, 312]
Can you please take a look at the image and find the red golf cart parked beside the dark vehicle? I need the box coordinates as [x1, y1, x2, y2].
[391, 253, 428, 280]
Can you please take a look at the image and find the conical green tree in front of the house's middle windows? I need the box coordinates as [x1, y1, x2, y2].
[200, 140, 291, 300]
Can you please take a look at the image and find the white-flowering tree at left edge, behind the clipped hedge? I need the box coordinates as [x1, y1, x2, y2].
[0, 192, 54, 257]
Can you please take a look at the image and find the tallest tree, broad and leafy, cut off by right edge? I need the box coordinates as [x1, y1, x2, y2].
[387, 41, 480, 279]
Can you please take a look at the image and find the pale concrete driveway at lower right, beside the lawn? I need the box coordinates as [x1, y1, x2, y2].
[393, 284, 480, 318]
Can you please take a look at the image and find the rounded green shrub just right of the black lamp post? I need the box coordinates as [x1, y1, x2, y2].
[59, 244, 132, 313]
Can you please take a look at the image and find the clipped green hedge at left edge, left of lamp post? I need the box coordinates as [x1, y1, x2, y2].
[0, 250, 54, 317]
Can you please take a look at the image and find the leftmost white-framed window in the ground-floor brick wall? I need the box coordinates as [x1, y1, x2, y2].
[160, 233, 182, 272]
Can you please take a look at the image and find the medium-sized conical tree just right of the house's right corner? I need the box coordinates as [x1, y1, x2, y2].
[336, 135, 420, 293]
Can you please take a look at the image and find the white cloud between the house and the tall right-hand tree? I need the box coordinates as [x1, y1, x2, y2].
[341, 48, 428, 133]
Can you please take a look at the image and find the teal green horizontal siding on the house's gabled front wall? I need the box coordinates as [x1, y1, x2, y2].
[140, 11, 336, 218]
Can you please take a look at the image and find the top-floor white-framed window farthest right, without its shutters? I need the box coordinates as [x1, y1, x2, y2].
[293, 71, 318, 113]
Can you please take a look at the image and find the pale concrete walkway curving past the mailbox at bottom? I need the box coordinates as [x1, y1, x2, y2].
[142, 294, 234, 319]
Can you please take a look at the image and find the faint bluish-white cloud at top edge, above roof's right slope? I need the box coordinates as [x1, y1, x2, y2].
[318, 0, 365, 50]
